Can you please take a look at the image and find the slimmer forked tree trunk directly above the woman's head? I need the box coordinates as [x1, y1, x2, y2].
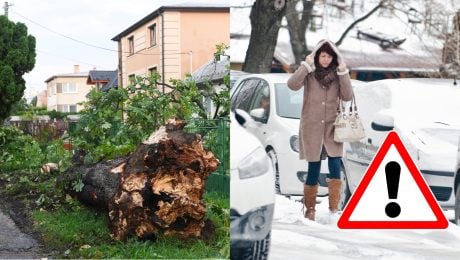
[286, 0, 315, 64]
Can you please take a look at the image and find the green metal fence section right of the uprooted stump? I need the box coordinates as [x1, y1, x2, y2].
[185, 119, 230, 194]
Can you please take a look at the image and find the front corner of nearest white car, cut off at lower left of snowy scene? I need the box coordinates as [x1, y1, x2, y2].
[230, 111, 275, 259]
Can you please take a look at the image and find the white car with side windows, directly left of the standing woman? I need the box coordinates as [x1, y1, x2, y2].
[230, 73, 358, 196]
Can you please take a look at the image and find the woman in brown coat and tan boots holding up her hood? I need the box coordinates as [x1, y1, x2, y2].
[287, 40, 353, 220]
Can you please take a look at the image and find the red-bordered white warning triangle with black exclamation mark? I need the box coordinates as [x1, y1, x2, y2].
[337, 131, 449, 229]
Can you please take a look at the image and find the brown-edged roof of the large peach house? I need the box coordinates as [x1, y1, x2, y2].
[112, 0, 230, 41]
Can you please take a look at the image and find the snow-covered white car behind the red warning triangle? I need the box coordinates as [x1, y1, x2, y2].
[342, 79, 460, 209]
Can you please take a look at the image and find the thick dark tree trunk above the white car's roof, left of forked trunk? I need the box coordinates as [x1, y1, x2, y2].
[243, 0, 286, 73]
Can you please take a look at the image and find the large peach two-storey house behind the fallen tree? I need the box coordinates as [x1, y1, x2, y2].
[112, 1, 230, 91]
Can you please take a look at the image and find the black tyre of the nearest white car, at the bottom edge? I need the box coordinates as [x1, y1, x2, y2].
[230, 232, 271, 260]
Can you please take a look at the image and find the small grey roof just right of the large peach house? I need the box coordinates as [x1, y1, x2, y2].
[192, 56, 230, 84]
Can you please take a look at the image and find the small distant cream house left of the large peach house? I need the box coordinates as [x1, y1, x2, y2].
[45, 65, 94, 112]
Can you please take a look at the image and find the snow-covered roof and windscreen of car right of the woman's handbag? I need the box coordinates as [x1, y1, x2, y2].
[355, 78, 460, 126]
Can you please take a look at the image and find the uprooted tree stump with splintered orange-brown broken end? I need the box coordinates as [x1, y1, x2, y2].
[58, 118, 219, 240]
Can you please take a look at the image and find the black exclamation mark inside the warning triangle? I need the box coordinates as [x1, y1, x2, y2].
[385, 161, 401, 218]
